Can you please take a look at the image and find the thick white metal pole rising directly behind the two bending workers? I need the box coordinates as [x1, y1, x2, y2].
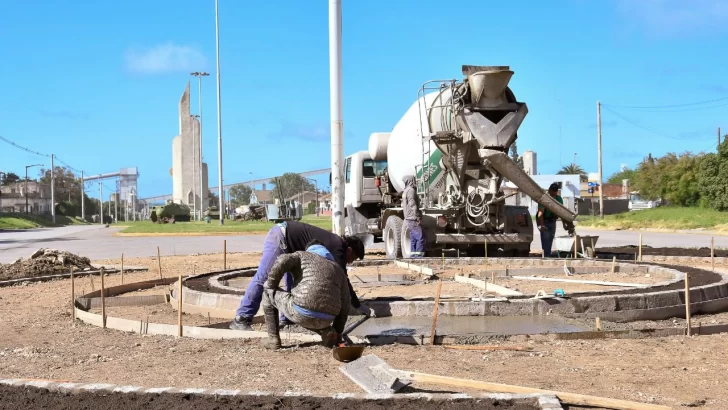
[329, 0, 344, 236]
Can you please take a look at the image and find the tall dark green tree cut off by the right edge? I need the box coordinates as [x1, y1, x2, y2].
[698, 139, 728, 212]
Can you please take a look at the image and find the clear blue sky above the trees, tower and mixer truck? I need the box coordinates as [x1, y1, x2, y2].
[0, 0, 728, 197]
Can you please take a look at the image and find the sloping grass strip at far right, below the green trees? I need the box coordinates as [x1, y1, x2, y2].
[578, 207, 728, 231]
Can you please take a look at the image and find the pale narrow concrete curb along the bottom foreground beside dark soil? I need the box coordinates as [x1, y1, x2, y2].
[0, 379, 563, 410]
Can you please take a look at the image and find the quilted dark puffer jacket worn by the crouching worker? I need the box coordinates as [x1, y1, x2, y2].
[265, 251, 351, 333]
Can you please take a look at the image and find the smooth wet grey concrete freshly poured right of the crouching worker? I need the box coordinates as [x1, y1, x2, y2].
[350, 316, 589, 337]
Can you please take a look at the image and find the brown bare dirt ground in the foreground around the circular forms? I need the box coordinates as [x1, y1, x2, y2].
[0, 253, 728, 409]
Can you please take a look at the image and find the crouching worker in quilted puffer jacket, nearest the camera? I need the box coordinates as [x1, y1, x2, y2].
[263, 240, 351, 349]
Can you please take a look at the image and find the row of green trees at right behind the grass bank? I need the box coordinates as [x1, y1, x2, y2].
[607, 137, 728, 211]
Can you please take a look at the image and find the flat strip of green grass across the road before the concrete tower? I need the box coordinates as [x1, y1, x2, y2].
[120, 215, 331, 234]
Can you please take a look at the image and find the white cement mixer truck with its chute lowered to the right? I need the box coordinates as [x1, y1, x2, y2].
[344, 65, 576, 259]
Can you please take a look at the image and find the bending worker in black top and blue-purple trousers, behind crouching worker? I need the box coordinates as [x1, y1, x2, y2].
[230, 221, 371, 330]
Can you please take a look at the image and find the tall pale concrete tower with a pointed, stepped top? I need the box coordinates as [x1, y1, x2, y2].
[172, 81, 208, 212]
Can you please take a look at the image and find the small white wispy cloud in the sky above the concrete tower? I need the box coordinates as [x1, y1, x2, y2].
[125, 43, 207, 74]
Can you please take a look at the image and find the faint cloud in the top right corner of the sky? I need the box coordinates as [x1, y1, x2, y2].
[618, 0, 728, 37]
